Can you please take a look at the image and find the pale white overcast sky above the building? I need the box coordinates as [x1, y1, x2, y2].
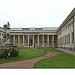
[0, 0, 75, 28]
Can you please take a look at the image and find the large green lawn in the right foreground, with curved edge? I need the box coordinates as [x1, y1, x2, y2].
[34, 54, 75, 68]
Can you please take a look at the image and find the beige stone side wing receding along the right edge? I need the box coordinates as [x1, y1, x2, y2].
[57, 8, 75, 49]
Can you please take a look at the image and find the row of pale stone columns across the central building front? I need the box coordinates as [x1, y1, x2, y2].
[13, 35, 54, 47]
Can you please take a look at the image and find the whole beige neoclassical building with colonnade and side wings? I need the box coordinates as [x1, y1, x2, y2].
[0, 8, 75, 49]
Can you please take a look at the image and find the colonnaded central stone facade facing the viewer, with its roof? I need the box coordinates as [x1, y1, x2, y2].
[10, 27, 57, 47]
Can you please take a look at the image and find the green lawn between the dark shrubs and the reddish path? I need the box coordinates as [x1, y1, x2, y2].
[0, 48, 46, 64]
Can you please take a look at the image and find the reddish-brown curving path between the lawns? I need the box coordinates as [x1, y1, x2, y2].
[0, 51, 63, 68]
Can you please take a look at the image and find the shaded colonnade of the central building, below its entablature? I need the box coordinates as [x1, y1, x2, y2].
[11, 35, 57, 47]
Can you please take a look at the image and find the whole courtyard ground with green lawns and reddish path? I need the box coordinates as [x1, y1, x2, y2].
[0, 48, 75, 68]
